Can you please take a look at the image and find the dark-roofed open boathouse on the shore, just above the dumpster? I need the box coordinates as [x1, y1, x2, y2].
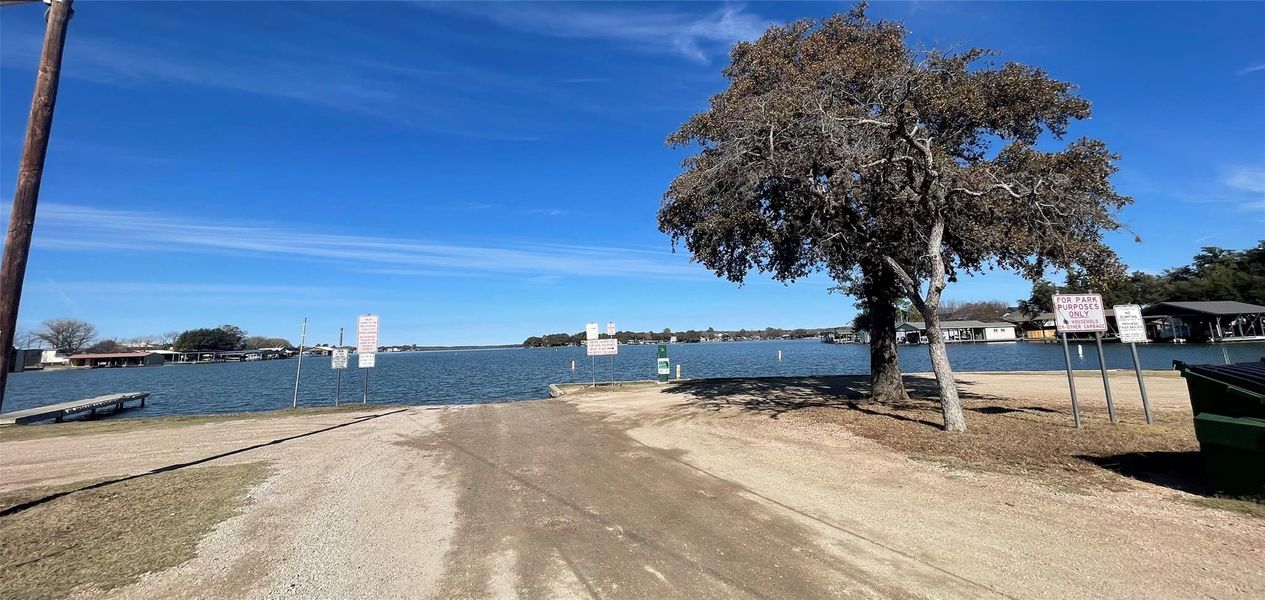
[1142, 300, 1265, 343]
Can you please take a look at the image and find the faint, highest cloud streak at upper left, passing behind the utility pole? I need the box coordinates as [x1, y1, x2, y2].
[0, 23, 541, 142]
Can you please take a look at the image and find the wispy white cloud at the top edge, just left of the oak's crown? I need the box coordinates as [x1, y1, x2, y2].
[429, 3, 768, 63]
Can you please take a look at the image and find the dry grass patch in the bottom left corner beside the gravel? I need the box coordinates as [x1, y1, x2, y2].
[0, 462, 267, 599]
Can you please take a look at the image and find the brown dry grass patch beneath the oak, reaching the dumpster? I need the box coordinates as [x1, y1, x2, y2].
[793, 397, 1265, 518]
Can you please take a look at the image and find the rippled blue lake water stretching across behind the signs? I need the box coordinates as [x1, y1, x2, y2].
[4, 339, 1265, 418]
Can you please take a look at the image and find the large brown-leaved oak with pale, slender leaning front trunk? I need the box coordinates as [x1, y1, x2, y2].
[659, 4, 1130, 430]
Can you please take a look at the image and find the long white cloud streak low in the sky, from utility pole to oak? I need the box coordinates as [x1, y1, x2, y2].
[37, 203, 707, 278]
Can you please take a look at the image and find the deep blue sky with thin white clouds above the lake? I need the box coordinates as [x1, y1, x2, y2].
[0, 0, 1265, 344]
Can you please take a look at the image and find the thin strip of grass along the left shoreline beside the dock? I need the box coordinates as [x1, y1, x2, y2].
[0, 404, 396, 442]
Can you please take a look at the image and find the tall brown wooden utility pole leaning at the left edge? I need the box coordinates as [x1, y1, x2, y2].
[0, 0, 73, 408]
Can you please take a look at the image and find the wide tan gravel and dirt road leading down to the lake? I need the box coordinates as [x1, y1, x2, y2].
[0, 377, 1265, 597]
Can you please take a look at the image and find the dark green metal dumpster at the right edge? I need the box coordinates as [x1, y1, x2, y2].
[1173, 359, 1265, 497]
